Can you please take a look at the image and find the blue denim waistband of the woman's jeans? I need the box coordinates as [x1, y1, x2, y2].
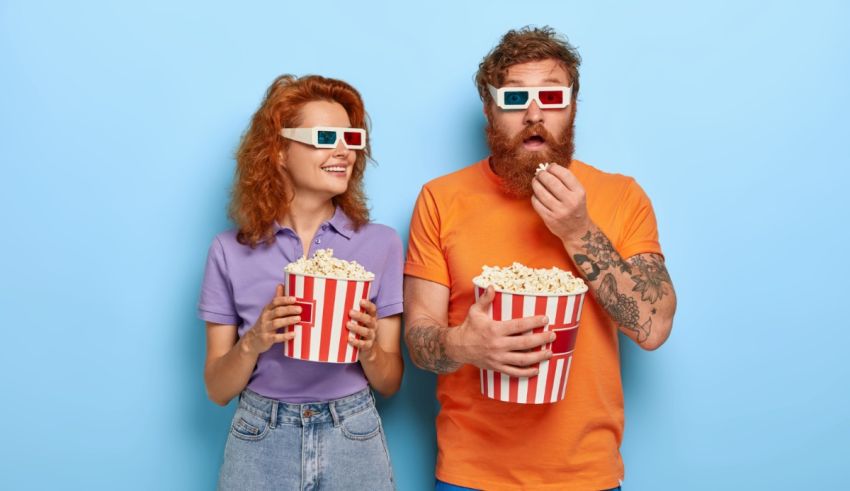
[239, 387, 375, 428]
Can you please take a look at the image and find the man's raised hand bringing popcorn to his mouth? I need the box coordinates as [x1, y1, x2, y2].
[531, 165, 591, 242]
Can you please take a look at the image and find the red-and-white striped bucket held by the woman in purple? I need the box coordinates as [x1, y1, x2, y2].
[283, 273, 372, 363]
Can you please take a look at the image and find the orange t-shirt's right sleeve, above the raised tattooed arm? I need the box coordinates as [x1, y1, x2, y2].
[619, 179, 662, 259]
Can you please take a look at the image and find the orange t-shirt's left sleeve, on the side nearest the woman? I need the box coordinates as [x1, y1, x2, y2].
[404, 187, 449, 287]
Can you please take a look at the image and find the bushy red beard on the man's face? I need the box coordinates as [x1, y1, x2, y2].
[486, 121, 575, 198]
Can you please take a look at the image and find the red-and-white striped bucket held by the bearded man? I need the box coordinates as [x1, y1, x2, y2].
[474, 285, 585, 404]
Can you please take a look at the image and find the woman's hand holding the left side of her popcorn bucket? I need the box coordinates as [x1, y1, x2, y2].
[242, 285, 301, 355]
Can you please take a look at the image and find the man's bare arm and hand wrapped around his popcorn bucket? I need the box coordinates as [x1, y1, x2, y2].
[404, 276, 555, 377]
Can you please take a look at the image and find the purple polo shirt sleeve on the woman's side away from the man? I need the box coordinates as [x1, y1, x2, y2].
[198, 237, 239, 325]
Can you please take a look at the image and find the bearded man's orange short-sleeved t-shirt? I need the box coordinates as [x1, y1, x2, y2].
[404, 159, 661, 490]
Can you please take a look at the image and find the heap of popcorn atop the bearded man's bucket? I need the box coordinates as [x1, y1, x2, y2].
[472, 262, 587, 295]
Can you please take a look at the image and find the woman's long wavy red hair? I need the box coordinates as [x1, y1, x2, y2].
[229, 75, 371, 248]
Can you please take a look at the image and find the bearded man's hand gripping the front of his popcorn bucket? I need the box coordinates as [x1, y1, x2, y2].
[446, 286, 555, 377]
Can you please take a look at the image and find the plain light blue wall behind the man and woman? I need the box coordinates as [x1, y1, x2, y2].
[0, 0, 850, 490]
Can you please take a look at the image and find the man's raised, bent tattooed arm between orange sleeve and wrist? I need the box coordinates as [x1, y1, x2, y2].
[564, 227, 676, 350]
